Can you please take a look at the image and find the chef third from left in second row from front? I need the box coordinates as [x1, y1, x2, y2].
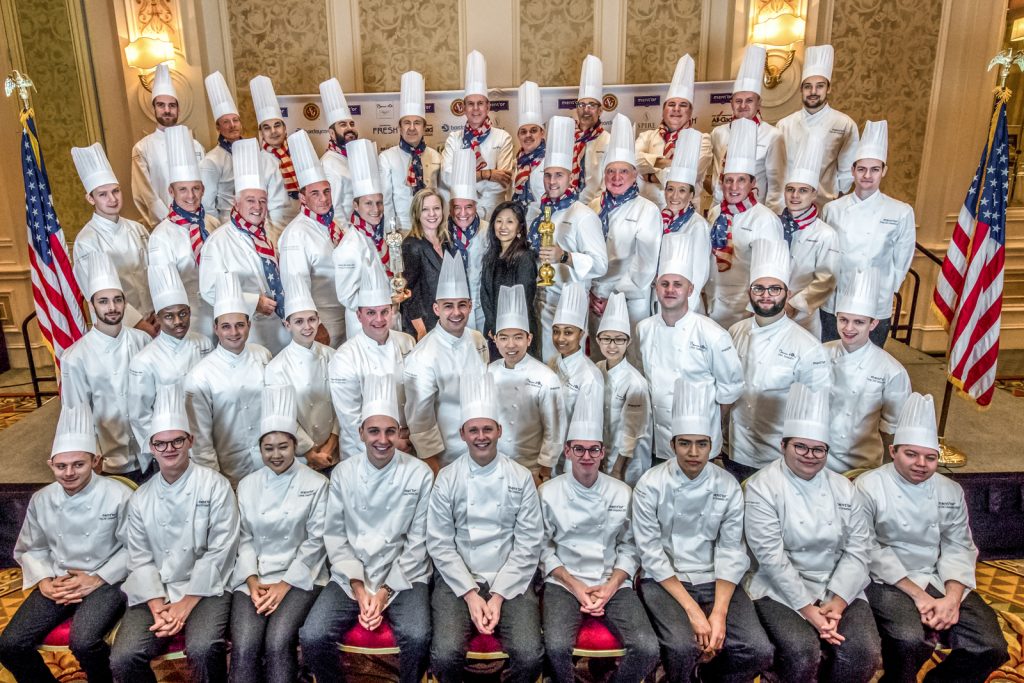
[184, 273, 270, 486]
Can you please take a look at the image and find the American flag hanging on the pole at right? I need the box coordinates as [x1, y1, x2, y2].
[933, 93, 1010, 408]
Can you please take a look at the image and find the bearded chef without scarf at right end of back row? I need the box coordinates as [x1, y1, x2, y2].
[775, 45, 860, 208]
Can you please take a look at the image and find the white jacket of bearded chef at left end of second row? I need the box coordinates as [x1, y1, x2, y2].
[60, 326, 150, 473]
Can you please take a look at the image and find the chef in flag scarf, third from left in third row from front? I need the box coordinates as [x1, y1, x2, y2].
[199, 139, 289, 354]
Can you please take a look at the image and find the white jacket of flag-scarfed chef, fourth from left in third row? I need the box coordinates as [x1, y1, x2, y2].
[278, 212, 348, 348]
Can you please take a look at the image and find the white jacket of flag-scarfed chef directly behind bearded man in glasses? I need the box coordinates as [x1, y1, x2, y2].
[708, 202, 785, 330]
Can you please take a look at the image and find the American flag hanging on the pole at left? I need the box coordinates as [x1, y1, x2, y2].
[22, 110, 85, 367]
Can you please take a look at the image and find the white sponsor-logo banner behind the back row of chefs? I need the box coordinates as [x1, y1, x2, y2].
[278, 81, 732, 154]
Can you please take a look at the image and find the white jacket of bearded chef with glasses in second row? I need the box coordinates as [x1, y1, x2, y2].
[729, 315, 831, 467]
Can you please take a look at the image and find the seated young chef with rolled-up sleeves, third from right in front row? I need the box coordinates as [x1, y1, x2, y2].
[633, 378, 772, 683]
